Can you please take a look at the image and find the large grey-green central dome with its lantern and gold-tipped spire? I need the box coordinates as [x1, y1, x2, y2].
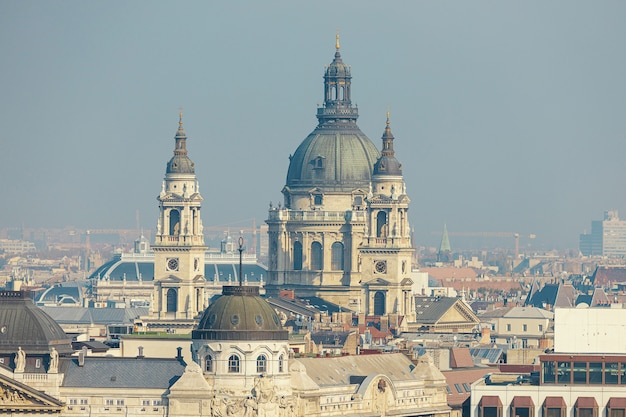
[286, 41, 380, 193]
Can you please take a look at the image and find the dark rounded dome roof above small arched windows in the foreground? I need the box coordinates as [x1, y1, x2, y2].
[192, 286, 288, 340]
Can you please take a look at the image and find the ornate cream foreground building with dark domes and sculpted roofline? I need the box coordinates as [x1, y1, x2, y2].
[0, 286, 450, 417]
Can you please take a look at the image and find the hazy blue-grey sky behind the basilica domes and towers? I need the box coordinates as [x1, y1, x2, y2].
[0, 0, 626, 249]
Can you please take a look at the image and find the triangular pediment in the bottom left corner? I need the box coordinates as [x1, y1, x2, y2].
[0, 375, 63, 412]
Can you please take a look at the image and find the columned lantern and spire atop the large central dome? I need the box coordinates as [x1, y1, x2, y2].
[317, 34, 359, 124]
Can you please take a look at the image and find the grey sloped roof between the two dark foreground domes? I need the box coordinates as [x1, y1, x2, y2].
[63, 357, 185, 389]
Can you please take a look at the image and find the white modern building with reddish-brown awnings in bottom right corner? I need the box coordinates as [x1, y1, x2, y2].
[470, 307, 626, 417]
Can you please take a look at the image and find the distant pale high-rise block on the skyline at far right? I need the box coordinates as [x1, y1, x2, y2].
[579, 210, 626, 257]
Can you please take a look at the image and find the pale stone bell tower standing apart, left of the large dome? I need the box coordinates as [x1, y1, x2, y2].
[150, 113, 207, 324]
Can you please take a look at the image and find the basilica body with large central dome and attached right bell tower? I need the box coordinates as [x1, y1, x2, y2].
[267, 38, 414, 319]
